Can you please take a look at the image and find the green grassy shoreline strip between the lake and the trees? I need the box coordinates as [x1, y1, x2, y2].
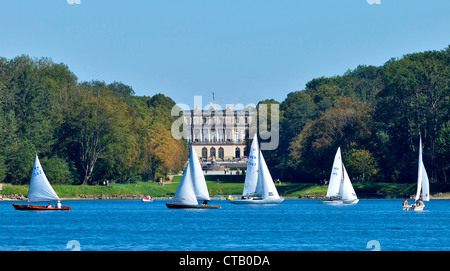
[1, 175, 450, 199]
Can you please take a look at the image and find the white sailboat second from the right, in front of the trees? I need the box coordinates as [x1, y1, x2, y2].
[322, 147, 359, 204]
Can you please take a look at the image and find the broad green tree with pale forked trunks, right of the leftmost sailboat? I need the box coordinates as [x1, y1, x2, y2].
[59, 86, 126, 184]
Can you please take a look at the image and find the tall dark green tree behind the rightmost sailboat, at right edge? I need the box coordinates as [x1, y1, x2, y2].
[376, 49, 450, 184]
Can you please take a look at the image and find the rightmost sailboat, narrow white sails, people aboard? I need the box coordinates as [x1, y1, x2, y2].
[403, 137, 430, 211]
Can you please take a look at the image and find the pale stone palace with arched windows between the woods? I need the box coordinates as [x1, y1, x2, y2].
[183, 103, 256, 160]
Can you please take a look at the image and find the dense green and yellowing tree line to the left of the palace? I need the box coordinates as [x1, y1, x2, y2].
[0, 56, 187, 187]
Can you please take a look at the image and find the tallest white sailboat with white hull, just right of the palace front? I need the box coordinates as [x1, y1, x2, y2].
[230, 134, 284, 204]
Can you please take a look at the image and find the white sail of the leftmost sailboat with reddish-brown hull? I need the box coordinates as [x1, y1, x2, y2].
[28, 154, 59, 202]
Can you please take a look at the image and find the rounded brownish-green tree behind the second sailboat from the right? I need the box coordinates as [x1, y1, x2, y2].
[289, 98, 373, 183]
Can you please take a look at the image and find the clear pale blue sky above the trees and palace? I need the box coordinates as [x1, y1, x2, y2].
[0, 0, 450, 106]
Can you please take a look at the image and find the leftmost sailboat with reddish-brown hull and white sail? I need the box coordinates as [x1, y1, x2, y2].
[13, 154, 72, 211]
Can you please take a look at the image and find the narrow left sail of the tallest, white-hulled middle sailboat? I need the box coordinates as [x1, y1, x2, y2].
[242, 133, 259, 196]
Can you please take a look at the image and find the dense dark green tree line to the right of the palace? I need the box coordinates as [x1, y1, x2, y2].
[262, 47, 450, 186]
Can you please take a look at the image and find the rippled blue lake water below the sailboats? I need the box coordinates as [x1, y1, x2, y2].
[0, 199, 450, 251]
